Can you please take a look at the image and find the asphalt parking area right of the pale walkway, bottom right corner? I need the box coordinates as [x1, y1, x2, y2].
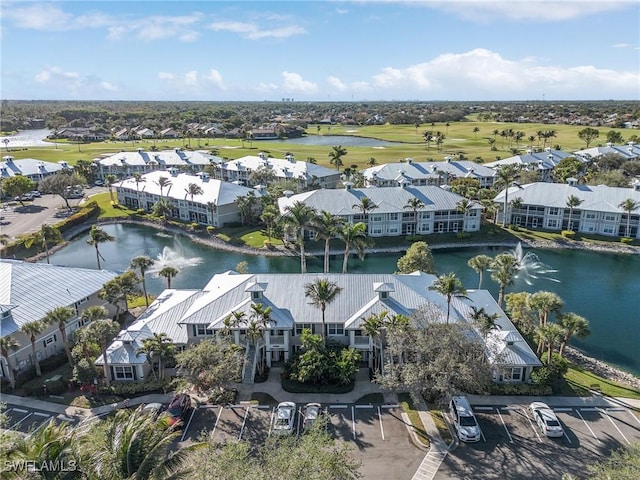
[435, 405, 640, 479]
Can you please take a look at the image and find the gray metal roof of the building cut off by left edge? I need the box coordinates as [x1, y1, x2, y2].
[0, 259, 118, 336]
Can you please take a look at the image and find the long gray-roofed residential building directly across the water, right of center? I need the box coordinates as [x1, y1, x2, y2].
[278, 182, 482, 238]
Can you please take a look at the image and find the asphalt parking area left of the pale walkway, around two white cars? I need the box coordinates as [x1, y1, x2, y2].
[180, 404, 425, 479]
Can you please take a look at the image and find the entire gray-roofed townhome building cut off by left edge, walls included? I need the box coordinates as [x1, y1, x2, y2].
[0, 259, 117, 378]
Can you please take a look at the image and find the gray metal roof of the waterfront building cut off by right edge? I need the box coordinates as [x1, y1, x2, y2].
[493, 182, 640, 213]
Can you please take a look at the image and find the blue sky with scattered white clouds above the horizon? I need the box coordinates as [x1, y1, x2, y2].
[0, 0, 640, 101]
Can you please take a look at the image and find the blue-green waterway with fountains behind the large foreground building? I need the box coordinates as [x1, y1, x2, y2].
[46, 224, 640, 376]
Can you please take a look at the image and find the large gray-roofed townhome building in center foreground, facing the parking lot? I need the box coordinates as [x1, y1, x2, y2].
[97, 271, 540, 383]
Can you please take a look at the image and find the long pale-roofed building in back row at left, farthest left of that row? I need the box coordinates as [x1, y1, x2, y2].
[94, 148, 222, 180]
